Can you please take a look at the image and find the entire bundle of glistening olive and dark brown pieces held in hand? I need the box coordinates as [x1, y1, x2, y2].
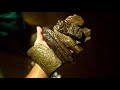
[28, 14, 91, 75]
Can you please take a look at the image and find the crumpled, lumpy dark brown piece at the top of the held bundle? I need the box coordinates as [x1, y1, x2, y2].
[54, 14, 91, 42]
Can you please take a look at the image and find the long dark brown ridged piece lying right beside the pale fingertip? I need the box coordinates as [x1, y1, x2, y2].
[43, 27, 73, 63]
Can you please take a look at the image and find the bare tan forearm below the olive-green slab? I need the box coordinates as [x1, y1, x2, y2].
[26, 63, 48, 78]
